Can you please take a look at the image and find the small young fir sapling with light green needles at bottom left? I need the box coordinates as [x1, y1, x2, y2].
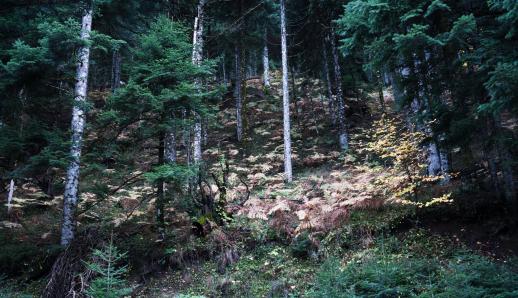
[86, 242, 131, 298]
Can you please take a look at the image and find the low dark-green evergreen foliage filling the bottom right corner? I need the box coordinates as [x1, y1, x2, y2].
[309, 239, 518, 297]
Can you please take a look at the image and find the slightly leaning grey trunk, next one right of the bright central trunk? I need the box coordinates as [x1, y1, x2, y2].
[331, 33, 349, 151]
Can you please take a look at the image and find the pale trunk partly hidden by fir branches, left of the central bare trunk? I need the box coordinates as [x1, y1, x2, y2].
[192, 0, 205, 164]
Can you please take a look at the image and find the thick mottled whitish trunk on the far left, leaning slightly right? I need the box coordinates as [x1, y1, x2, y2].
[61, 5, 93, 245]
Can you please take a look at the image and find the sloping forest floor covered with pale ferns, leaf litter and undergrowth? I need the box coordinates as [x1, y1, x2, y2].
[0, 76, 518, 297]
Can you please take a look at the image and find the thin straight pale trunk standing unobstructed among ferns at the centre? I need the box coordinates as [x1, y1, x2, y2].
[281, 0, 293, 183]
